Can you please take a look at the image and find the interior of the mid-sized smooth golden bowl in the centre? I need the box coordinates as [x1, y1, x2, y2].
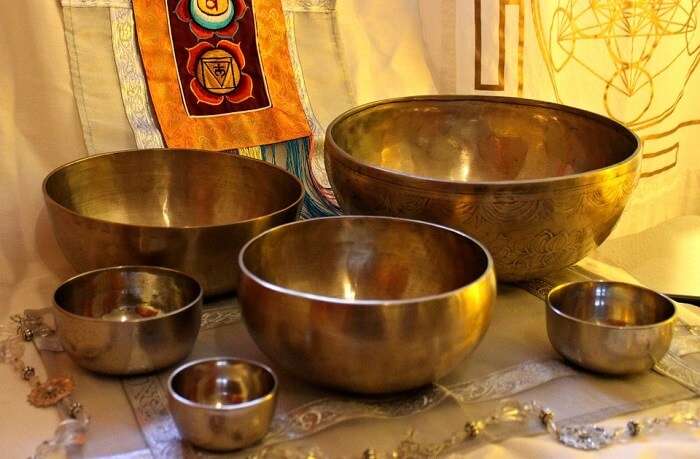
[242, 217, 488, 300]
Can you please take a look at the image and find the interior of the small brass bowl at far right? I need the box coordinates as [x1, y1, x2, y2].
[549, 281, 675, 327]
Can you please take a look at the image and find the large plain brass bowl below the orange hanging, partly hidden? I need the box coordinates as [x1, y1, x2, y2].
[43, 149, 304, 296]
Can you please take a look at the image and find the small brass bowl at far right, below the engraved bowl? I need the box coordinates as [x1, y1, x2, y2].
[547, 281, 676, 375]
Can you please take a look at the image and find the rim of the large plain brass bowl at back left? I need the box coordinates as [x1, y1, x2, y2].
[41, 148, 306, 231]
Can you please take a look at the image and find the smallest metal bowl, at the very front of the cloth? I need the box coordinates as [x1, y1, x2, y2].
[168, 357, 277, 451]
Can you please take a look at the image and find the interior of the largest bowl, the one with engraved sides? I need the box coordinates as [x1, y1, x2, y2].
[331, 97, 638, 182]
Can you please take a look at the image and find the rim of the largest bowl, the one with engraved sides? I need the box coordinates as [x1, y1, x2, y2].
[325, 94, 642, 191]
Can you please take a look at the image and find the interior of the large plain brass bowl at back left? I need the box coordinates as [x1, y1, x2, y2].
[45, 150, 302, 227]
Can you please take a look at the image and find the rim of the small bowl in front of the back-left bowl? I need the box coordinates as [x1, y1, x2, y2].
[52, 265, 204, 327]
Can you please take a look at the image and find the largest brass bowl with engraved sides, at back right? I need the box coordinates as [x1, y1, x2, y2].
[325, 96, 641, 281]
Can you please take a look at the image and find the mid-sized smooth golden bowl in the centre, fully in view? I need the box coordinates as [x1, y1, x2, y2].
[238, 217, 496, 393]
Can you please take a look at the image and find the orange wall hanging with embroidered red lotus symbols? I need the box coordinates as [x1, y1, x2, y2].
[133, 0, 310, 150]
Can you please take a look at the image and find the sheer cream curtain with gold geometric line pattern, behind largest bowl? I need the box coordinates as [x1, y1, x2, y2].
[418, 0, 700, 238]
